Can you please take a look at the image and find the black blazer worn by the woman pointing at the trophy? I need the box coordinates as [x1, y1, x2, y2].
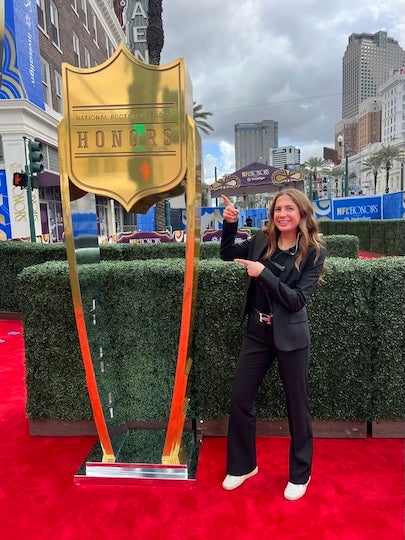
[220, 221, 326, 351]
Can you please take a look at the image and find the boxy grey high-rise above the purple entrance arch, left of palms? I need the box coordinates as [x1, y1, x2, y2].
[235, 120, 278, 170]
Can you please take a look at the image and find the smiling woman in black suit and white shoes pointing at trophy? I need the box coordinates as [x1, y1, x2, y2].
[220, 188, 326, 500]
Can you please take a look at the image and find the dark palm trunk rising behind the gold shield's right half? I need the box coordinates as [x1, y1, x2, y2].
[146, 0, 165, 231]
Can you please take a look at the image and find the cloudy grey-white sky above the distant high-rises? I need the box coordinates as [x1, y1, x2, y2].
[161, 0, 405, 183]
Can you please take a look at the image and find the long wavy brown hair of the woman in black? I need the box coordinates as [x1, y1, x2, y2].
[264, 188, 325, 270]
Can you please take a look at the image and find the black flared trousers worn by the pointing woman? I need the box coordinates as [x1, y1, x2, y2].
[227, 318, 313, 484]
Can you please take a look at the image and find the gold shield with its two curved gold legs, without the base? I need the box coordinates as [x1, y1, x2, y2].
[58, 46, 201, 474]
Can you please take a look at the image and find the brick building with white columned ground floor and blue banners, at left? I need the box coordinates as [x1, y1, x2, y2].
[0, 0, 125, 242]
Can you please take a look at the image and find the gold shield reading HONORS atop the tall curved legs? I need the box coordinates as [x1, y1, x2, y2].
[62, 45, 192, 212]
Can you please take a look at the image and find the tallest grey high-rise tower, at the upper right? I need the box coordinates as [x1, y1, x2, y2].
[342, 30, 405, 118]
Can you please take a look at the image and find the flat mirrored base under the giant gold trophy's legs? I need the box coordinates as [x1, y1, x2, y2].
[74, 430, 200, 488]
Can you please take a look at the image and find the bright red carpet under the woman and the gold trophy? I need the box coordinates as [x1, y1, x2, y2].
[0, 321, 404, 540]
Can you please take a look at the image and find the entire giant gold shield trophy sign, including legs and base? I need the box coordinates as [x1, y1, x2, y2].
[58, 45, 201, 483]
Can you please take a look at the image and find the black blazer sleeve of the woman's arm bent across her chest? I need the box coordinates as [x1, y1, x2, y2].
[257, 246, 326, 312]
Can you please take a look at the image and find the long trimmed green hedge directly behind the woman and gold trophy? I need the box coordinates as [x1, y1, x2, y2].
[17, 257, 405, 423]
